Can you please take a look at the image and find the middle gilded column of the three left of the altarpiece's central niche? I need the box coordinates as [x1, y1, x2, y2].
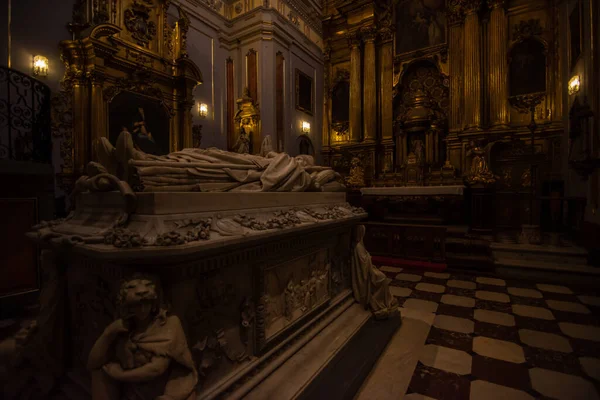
[362, 28, 377, 142]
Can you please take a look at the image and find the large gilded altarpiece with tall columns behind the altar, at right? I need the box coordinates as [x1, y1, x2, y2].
[323, 0, 563, 194]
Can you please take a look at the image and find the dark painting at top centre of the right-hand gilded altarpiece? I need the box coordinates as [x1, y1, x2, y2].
[394, 0, 447, 55]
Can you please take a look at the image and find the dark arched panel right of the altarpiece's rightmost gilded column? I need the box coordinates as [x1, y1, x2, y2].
[509, 37, 547, 97]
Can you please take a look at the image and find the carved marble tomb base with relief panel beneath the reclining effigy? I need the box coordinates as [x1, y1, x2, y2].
[21, 192, 399, 399]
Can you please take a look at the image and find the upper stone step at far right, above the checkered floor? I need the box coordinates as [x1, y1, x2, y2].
[490, 243, 588, 265]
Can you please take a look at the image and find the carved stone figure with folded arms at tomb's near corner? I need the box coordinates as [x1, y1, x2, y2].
[88, 274, 198, 400]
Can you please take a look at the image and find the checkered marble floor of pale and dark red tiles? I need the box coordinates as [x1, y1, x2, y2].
[380, 267, 600, 400]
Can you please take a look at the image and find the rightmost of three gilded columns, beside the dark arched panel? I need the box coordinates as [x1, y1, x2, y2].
[488, 0, 509, 129]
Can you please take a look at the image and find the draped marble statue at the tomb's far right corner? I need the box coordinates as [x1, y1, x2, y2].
[352, 225, 398, 319]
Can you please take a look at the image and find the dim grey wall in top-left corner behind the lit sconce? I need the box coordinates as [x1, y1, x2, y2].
[0, 0, 73, 91]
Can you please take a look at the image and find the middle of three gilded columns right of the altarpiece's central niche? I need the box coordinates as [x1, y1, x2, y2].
[464, 0, 481, 130]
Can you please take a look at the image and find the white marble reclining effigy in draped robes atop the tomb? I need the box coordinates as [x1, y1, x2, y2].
[96, 132, 345, 192]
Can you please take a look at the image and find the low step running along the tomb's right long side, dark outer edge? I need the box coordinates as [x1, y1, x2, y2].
[241, 303, 401, 400]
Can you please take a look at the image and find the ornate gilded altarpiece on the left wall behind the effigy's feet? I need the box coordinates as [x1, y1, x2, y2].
[53, 0, 202, 192]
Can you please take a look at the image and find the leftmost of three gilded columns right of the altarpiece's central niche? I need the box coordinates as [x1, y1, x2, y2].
[448, 0, 465, 132]
